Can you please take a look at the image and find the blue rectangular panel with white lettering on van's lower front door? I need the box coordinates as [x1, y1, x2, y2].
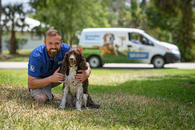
[128, 52, 149, 59]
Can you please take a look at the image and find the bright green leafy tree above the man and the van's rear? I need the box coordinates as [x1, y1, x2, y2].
[31, 0, 108, 44]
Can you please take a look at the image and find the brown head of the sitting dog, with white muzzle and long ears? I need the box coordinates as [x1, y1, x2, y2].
[61, 49, 87, 72]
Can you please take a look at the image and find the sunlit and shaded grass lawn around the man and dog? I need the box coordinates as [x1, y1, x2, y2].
[0, 69, 195, 129]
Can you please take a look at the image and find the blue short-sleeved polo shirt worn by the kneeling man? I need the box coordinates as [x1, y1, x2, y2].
[28, 43, 71, 78]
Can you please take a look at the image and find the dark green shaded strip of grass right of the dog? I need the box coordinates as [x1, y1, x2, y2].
[89, 75, 195, 104]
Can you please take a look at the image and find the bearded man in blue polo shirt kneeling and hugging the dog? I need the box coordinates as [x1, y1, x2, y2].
[28, 29, 100, 108]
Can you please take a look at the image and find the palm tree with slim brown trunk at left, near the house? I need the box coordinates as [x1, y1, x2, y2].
[2, 4, 28, 54]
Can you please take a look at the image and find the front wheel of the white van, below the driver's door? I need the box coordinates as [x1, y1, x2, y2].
[152, 56, 165, 68]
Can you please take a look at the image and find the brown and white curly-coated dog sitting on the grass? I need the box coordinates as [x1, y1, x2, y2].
[59, 49, 88, 110]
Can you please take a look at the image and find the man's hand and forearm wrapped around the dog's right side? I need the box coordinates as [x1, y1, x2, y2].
[75, 63, 91, 83]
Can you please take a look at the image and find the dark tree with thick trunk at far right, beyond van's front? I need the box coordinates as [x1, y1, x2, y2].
[153, 0, 193, 61]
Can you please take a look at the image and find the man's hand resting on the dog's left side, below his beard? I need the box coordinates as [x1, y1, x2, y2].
[50, 67, 64, 83]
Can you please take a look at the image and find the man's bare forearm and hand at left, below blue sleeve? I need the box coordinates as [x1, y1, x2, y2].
[28, 68, 64, 89]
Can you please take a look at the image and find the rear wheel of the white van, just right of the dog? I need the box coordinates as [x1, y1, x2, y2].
[88, 56, 101, 68]
